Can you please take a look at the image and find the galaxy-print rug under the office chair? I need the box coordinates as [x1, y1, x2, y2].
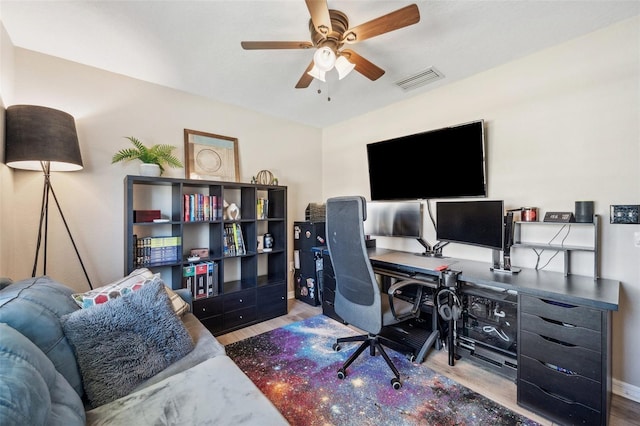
[225, 315, 538, 426]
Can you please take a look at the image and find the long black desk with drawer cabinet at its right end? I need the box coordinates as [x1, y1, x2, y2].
[318, 248, 620, 425]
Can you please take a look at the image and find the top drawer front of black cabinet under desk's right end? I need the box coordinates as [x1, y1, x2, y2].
[520, 294, 602, 331]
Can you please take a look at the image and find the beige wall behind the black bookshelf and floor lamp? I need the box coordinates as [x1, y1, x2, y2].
[0, 35, 321, 290]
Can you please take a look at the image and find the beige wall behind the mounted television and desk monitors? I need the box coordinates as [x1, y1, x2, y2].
[322, 18, 640, 399]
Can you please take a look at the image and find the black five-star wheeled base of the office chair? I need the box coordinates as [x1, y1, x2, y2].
[333, 334, 415, 389]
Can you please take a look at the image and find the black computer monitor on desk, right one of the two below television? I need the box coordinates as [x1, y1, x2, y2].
[436, 200, 504, 250]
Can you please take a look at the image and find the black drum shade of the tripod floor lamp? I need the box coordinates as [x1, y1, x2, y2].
[4, 105, 83, 171]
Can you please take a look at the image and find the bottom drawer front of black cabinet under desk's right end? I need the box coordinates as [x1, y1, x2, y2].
[518, 381, 604, 425]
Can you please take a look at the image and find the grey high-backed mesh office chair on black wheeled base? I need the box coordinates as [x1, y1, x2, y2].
[325, 196, 438, 389]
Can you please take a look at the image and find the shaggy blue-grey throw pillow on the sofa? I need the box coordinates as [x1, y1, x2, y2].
[61, 280, 194, 407]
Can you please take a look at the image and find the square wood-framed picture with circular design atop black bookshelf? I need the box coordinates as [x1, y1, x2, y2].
[184, 129, 240, 182]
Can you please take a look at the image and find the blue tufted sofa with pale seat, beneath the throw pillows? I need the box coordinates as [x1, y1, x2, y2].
[0, 276, 288, 426]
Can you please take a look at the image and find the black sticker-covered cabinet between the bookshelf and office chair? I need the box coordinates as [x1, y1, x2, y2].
[293, 221, 326, 306]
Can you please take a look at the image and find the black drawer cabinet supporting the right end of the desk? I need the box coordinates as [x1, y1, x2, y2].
[518, 294, 611, 425]
